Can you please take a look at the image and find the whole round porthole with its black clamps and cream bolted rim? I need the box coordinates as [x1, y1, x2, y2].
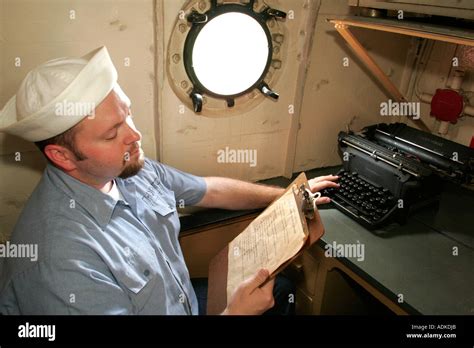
[168, 0, 286, 113]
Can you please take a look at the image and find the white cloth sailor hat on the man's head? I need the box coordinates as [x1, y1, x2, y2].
[0, 46, 130, 142]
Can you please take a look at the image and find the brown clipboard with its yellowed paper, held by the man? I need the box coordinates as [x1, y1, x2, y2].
[208, 173, 324, 314]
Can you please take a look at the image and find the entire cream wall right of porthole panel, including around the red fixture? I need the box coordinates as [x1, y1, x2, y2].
[294, 0, 474, 172]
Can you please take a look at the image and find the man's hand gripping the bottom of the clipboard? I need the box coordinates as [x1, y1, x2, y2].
[222, 269, 275, 315]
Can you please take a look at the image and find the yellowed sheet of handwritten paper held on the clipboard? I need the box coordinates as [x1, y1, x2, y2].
[227, 189, 308, 299]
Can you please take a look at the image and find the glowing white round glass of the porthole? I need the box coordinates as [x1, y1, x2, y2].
[192, 12, 269, 96]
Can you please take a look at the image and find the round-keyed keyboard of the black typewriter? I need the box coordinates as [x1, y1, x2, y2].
[321, 171, 397, 228]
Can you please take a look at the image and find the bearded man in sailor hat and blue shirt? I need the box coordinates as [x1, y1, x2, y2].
[0, 47, 337, 314]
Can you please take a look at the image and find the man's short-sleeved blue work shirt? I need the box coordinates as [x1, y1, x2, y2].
[0, 159, 206, 314]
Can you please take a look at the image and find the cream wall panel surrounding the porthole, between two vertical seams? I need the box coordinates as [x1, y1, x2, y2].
[158, 0, 311, 181]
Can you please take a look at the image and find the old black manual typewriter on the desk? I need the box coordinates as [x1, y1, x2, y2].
[321, 123, 474, 229]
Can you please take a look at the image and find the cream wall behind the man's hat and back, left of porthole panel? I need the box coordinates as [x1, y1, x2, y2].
[0, 0, 157, 240]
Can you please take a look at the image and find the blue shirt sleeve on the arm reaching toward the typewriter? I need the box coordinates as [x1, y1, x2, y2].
[151, 161, 207, 206]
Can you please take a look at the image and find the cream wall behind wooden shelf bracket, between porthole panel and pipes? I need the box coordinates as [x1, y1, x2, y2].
[294, 0, 410, 171]
